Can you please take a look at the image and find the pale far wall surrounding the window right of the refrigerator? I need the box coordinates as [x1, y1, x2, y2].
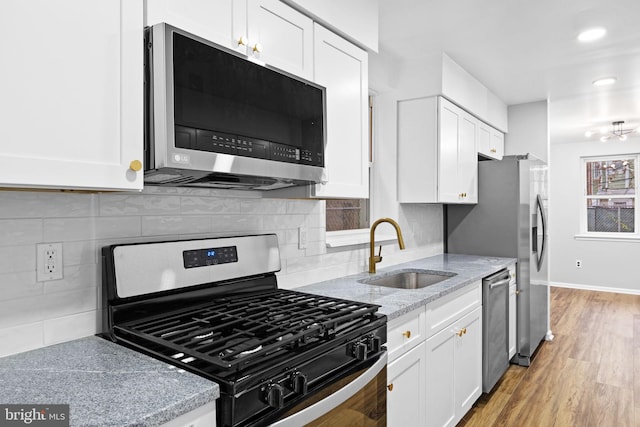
[549, 138, 640, 294]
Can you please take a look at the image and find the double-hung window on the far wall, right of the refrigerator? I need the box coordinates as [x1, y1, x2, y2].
[583, 155, 640, 235]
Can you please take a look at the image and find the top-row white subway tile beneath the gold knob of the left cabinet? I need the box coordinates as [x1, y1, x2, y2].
[100, 194, 180, 216]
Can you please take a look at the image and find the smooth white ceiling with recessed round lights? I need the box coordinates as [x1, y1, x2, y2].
[379, 0, 640, 143]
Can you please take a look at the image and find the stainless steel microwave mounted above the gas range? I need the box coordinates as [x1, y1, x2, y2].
[144, 23, 326, 190]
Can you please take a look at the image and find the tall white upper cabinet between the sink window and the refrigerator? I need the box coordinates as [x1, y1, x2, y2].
[398, 96, 478, 203]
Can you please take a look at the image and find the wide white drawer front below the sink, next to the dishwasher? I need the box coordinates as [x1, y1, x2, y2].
[425, 281, 482, 338]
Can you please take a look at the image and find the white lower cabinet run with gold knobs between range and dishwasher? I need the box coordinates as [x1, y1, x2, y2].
[387, 282, 482, 427]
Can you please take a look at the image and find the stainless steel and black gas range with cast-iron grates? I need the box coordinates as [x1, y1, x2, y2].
[102, 234, 386, 427]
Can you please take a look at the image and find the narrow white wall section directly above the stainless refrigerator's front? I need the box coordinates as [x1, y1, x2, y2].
[504, 101, 549, 163]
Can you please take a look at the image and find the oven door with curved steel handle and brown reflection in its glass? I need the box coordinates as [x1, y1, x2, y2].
[271, 352, 387, 427]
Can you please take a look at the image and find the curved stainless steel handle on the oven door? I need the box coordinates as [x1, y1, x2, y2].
[271, 351, 387, 427]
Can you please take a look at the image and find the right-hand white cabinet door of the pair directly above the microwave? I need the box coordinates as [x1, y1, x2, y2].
[247, 0, 313, 80]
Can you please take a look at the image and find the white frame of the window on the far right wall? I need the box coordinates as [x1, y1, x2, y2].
[576, 153, 640, 241]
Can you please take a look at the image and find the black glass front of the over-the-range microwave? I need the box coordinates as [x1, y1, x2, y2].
[173, 33, 324, 166]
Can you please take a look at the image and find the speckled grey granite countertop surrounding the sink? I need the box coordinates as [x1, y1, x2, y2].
[296, 254, 517, 320]
